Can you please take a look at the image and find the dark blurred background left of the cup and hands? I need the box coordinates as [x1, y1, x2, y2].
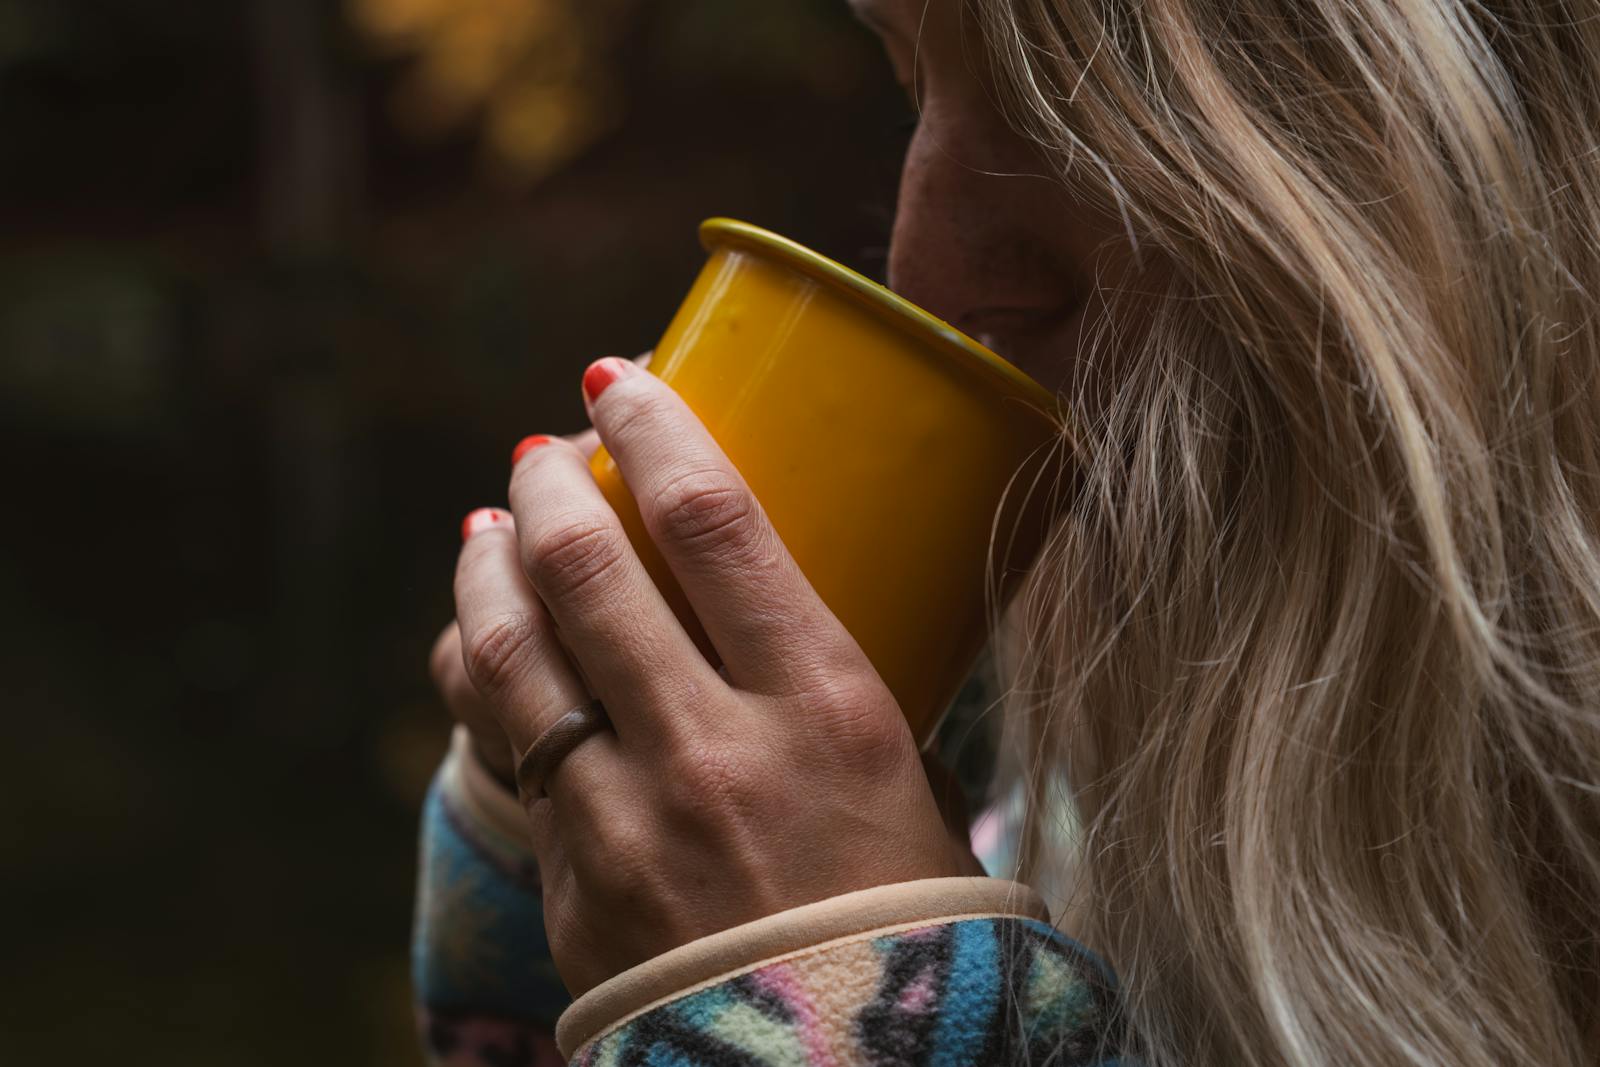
[0, 0, 907, 1067]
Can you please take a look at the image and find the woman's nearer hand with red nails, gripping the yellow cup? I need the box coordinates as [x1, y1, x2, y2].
[456, 360, 978, 995]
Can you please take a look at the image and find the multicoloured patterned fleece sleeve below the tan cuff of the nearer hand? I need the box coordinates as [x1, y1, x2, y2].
[573, 918, 1118, 1067]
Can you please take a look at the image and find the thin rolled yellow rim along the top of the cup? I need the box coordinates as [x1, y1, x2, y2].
[699, 216, 1061, 419]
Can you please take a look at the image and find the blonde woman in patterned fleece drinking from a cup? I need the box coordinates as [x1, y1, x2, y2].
[419, 0, 1600, 1065]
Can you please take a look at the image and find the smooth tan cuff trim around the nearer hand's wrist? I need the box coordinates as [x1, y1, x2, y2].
[555, 878, 1050, 1057]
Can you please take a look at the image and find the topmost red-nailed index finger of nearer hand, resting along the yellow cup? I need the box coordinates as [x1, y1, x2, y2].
[584, 358, 866, 691]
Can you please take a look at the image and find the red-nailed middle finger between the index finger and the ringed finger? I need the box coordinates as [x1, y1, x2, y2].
[510, 440, 726, 737]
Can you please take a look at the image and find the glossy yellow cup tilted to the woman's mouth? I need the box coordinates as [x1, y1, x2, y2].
[590, 219, 1059, 744]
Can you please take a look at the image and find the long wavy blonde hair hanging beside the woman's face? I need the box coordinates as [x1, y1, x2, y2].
[968, 0, 1600, 1067]
